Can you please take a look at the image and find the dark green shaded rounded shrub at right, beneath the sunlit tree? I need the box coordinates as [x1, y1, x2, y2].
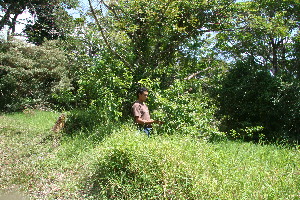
[217, 62, 300, 141]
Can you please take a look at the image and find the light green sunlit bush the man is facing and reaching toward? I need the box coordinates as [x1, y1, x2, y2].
[144, 79, 222, 140]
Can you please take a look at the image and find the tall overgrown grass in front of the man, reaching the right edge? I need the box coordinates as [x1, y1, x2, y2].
[85, 132, 300, 199]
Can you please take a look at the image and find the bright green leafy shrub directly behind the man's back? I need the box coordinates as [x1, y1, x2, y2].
[74, 57, 134, 122]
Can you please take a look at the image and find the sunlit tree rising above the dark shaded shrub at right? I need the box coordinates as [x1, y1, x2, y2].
[217, 0, 300, 75]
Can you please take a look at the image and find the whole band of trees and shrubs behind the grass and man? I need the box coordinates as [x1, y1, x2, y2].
[0, 0, 300, 141]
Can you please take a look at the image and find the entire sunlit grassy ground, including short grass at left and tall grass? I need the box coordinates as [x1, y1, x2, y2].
[0, 111, 300, 199]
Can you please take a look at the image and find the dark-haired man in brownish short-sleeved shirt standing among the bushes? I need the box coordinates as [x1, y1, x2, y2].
[132, 87, 164, 137]
